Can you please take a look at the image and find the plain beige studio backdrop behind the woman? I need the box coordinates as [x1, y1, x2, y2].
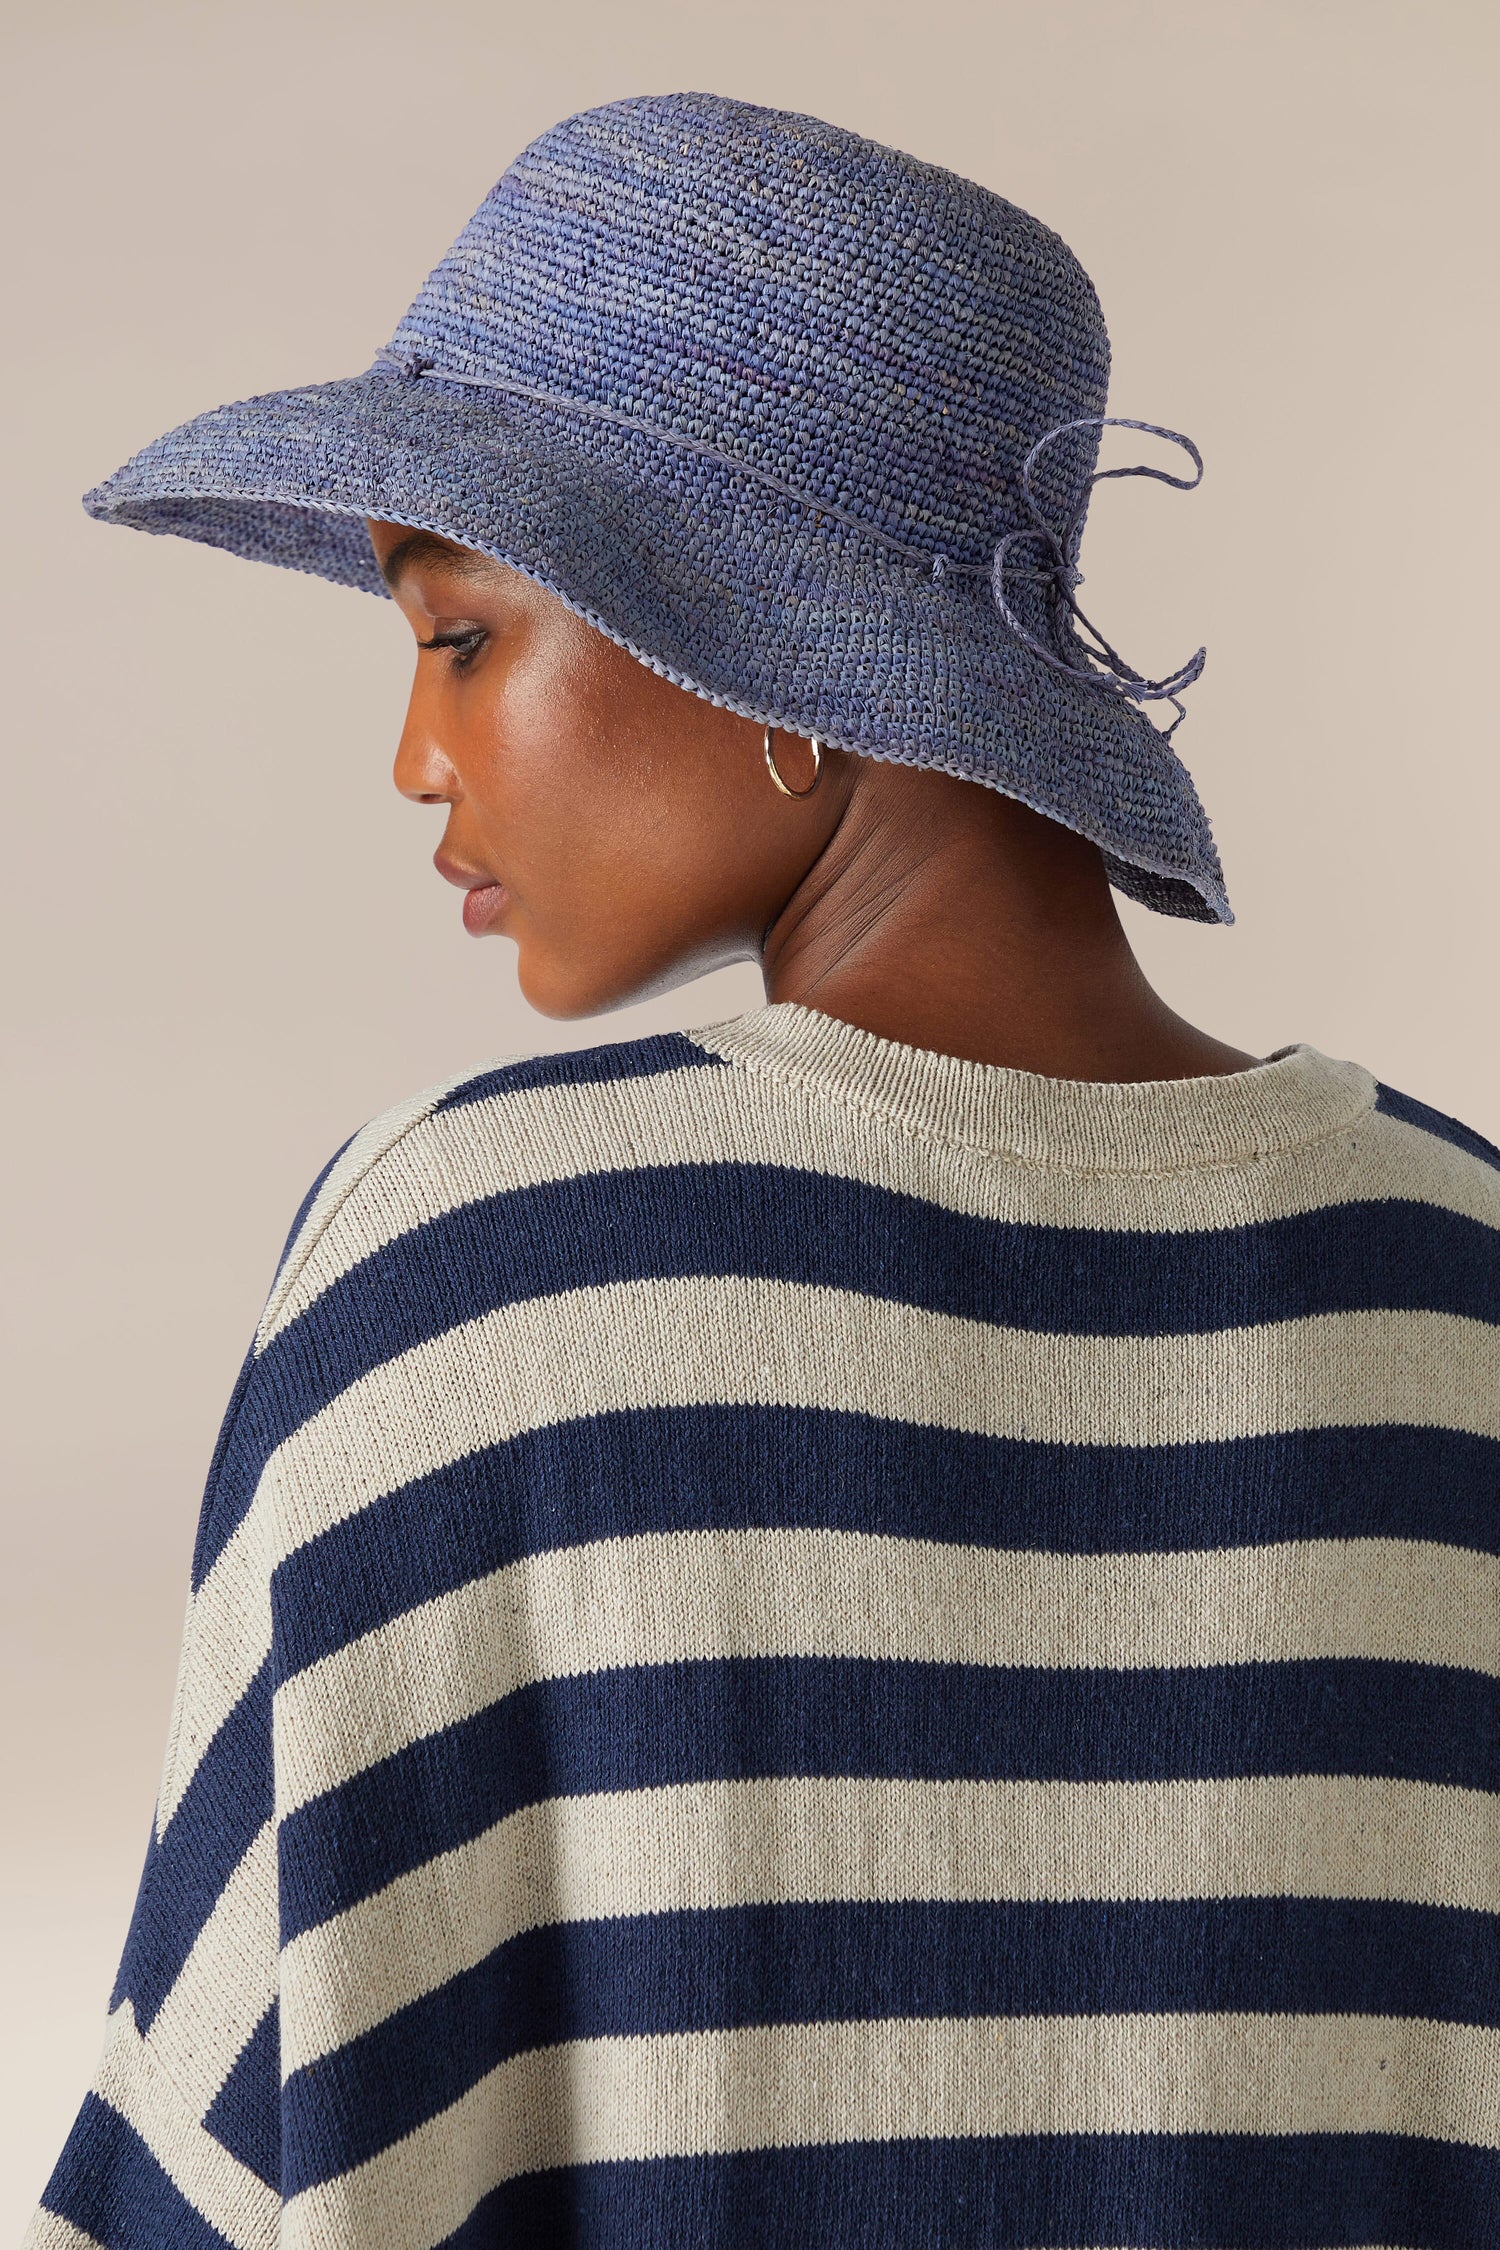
[0, 0, 1500, 2239]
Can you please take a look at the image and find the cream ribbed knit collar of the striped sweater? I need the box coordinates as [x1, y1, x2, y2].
[690, 1001, 1376, 1172]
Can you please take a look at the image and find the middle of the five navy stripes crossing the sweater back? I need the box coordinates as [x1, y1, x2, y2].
[281, 1658, 1500, 1944]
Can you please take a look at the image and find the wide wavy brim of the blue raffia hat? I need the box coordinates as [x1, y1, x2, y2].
[83, 369, 1232, 923]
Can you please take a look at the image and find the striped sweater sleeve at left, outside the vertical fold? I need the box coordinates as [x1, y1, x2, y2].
[25, 1314, 281, 2250]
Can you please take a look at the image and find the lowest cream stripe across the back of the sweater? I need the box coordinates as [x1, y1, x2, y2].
[283, 2016, 1500, 2250]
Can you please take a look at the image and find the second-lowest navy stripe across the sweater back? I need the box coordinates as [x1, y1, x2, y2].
[283, 1899, 1500, 2196]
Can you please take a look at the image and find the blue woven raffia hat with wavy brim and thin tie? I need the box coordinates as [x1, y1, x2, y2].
[85, 95, 1230, 920]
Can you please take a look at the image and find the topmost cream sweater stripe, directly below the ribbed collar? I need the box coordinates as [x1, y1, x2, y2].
[261, 1067, 1500, 1346]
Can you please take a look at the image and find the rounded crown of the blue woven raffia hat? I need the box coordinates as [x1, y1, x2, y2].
[391, 95, 1109, 563]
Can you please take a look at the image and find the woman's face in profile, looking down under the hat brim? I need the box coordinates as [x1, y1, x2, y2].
[369, 522, 846, 1017]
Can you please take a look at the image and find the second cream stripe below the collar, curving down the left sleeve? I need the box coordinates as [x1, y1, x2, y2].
[162, 1276, 1500, 1823]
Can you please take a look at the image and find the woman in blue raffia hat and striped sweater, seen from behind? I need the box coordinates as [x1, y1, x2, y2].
[31, 95, 1500, 2250]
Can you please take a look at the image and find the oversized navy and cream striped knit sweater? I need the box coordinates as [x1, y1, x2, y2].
[29, 1004, 1500, 2250]
